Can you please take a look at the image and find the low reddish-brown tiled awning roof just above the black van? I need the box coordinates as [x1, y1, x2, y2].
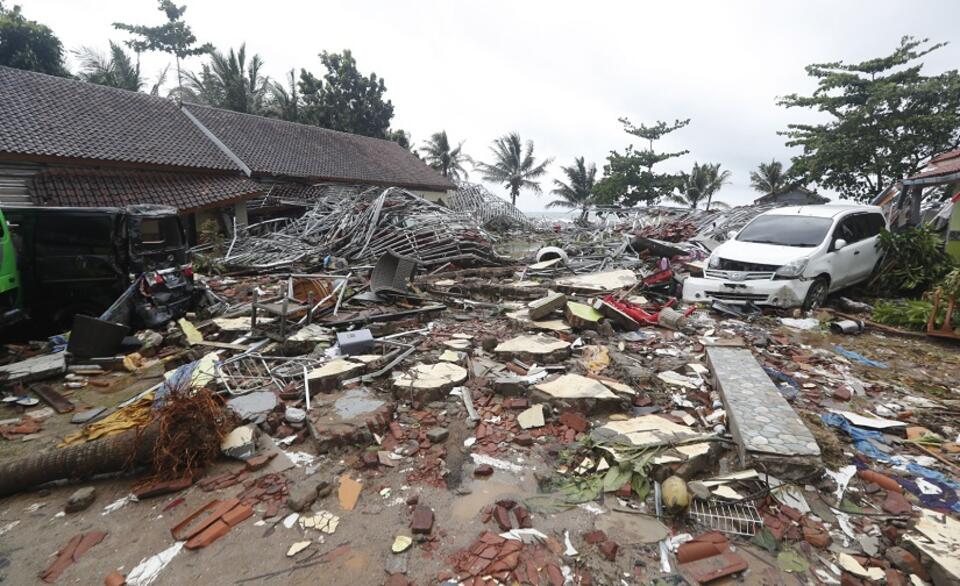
[30, 169, 266, 211]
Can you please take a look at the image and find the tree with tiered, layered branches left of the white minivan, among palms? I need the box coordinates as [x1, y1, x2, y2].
[597, 118, 690, 206]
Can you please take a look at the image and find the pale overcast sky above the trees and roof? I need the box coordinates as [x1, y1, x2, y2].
[18, 0, 960, 211]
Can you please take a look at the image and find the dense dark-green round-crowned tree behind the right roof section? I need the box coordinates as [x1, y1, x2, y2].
[300, 49, 393, 138]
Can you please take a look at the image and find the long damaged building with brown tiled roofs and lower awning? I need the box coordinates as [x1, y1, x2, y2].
[0, 67, 455, 242]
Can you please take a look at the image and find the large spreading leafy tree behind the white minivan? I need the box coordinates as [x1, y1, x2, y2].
[778, 37, 960, 201]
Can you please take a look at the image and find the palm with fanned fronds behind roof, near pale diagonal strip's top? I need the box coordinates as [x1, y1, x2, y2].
[184, 43, 270, 114]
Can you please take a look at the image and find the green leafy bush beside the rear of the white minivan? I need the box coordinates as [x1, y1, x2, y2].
[868, 226, 952, 297]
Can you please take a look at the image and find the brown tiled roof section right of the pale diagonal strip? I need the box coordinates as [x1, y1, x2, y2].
[184, 104, 455, 190]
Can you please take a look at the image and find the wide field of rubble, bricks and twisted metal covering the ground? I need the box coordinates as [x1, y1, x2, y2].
[0, 206, 960, 586]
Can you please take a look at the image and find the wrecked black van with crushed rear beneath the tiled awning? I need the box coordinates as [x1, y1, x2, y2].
[3, 205, 194, 331]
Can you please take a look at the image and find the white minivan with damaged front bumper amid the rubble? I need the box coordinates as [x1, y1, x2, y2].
[683, 205, 887, 310]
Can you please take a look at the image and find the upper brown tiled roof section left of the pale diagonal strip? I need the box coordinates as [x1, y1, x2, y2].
[0, 67, 238, 171]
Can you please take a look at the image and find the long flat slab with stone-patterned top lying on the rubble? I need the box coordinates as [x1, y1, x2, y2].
[707, 346, 820, 470]
